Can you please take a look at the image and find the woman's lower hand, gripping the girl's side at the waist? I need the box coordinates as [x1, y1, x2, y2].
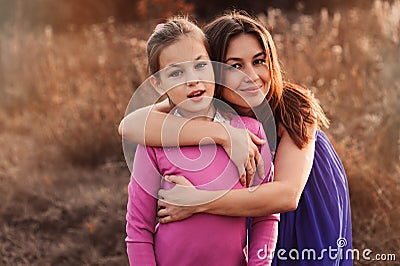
[157, 175, 200, 223]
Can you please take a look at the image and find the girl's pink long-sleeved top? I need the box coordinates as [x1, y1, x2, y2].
[126, 117, 279, 266]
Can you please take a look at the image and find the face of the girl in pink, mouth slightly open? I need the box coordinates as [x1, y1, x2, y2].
[158, 36, 215, 118]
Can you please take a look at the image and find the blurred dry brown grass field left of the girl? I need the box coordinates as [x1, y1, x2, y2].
[0, 18, 150, 265]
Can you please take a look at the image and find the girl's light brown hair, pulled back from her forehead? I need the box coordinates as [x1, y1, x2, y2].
[146, 17, 209, 75]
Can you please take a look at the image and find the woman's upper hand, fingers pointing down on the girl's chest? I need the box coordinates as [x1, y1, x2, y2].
[222, 125, 265, 186]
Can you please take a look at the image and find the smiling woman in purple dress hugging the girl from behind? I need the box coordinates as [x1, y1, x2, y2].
[120, 13, 352, 265]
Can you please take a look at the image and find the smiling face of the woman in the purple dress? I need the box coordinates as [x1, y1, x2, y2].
[222, 34, 271, 113]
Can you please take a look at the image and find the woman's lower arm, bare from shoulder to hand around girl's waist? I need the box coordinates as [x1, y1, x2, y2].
[158, 122, 316, 220]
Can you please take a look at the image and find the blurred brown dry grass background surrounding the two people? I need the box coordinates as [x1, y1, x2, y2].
[0, 0, 400, 265]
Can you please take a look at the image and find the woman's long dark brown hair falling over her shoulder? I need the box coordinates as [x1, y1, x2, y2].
[204, 11, 328, 148]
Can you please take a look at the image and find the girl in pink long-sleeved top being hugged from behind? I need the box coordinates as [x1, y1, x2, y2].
[126, 18, 279, 265]
